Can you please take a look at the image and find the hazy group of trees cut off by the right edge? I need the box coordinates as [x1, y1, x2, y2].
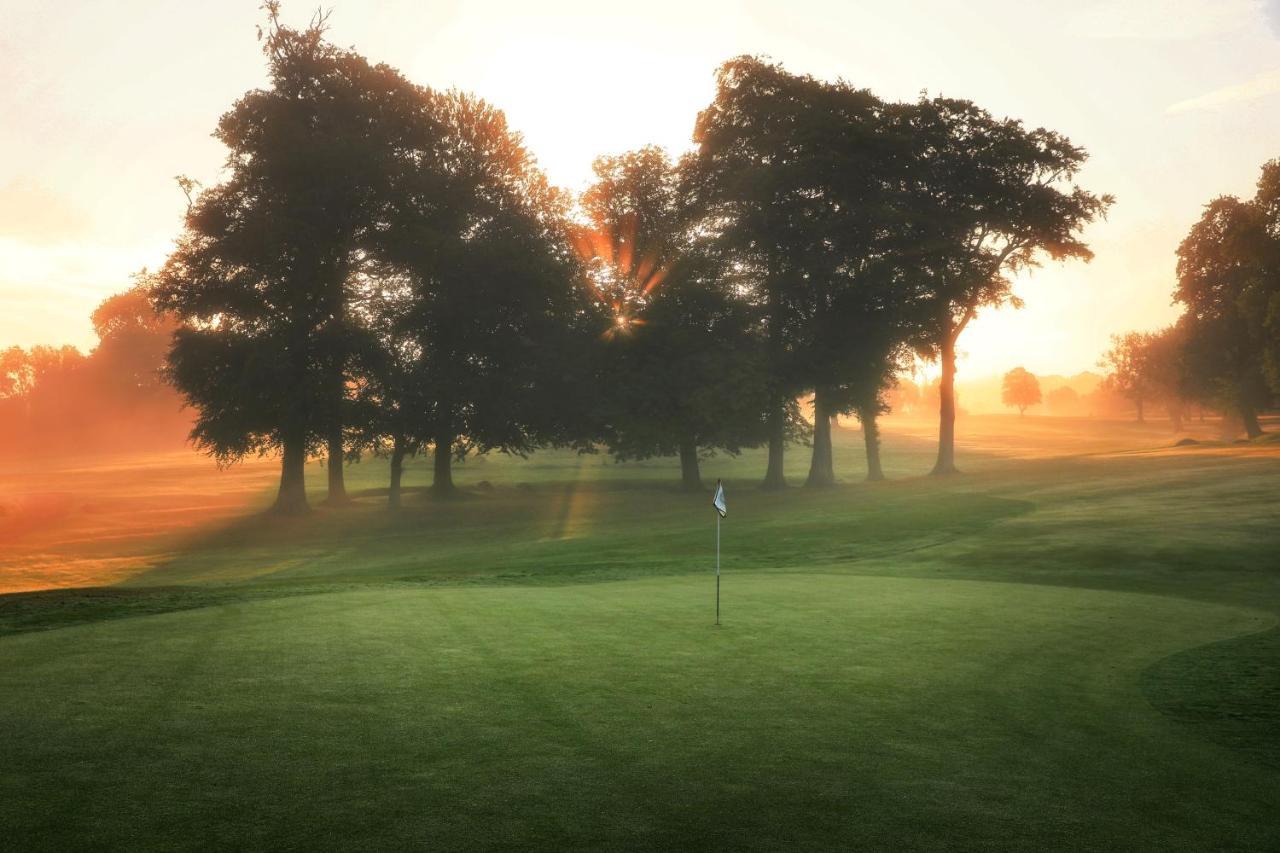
[1102, 160, 1280, 438]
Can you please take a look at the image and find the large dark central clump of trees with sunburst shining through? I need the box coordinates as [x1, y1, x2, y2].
[148, 4, 1111, 511]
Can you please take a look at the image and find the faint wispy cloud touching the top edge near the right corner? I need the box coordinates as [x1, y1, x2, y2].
[1074, 0, 1254, 41]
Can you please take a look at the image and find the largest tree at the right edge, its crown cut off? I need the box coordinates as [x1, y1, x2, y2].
[1174, 175, 1280, 438]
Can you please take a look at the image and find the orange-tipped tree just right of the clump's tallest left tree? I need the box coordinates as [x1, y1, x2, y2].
[372, 90, 600, 496]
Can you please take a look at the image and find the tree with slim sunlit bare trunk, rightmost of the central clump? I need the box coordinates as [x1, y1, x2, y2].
[896, 97, 1112, 474]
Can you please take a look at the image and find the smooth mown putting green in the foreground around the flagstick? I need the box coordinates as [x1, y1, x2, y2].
[0, 571, 1280, 850]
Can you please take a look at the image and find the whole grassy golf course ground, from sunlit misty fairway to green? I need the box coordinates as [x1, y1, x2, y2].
[0, 416, 1280, 850]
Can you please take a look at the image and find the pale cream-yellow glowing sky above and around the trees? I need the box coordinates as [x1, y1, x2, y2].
[0, 0, 1280, 377]
